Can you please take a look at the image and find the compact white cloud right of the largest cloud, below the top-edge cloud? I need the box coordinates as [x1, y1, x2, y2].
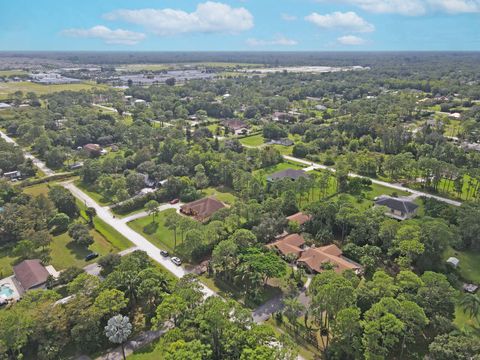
[305, 11, 375, 32]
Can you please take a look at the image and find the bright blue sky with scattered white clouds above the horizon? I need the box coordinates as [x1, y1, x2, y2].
[0, 0, 480, 51]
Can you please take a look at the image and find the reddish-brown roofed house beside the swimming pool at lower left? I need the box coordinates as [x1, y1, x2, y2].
[13, 259, 58, 293]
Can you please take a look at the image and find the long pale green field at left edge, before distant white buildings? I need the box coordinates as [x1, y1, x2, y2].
[0, 81, 108, 99]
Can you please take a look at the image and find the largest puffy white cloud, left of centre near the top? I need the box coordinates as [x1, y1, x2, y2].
[105, 1, 253, 36]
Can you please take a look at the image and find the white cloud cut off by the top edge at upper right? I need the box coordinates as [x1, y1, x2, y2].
[318, 0, 480, 16]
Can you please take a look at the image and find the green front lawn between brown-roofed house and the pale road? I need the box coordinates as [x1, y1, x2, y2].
[128, 209, 181, 253]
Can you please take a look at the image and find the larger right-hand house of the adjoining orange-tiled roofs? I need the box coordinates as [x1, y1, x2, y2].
[297, 244, 362, 274]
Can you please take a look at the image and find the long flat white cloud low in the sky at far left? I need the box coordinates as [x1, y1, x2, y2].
[62, 25, 145, 45]
